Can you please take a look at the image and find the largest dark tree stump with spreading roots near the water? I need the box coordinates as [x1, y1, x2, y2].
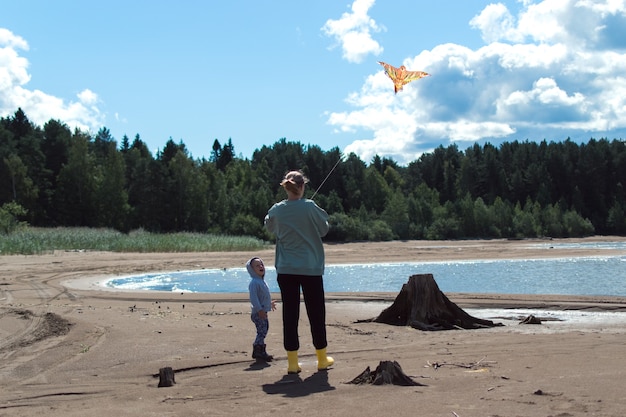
[370, 274, 503, 331]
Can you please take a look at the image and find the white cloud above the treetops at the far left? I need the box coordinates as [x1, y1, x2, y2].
[0, 28, 104, 131]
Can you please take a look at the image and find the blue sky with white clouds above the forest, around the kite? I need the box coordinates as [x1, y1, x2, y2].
[0, 0, 626, 164]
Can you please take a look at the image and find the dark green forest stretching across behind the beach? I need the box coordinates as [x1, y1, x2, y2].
[0, 109, 626, 242]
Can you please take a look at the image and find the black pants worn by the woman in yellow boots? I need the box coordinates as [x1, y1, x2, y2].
[277, 274, 328, 351]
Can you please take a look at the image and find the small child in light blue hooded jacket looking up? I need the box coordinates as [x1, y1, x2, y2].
[246, 257, 276, 362]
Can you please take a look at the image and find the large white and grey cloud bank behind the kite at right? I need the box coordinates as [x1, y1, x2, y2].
[328, 0, 626, 163]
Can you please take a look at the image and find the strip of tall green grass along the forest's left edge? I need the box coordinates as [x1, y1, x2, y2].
[0, 227, 270, 255]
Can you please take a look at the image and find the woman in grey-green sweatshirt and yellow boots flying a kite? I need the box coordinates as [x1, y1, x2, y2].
[265, 171, 335, 374]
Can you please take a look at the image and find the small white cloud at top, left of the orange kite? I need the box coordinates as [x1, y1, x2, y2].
[322, 0, 383, 63]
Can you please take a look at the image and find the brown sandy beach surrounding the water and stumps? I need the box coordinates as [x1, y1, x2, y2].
[0, 237, 626, 417]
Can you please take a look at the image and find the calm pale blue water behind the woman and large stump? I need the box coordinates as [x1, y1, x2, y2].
[106, 242, 626, 296]
